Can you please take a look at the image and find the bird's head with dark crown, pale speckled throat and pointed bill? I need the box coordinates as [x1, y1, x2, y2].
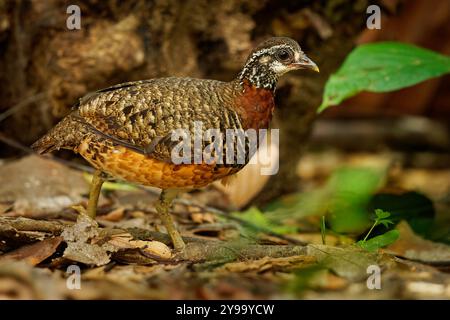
[239, 37, 319, 90]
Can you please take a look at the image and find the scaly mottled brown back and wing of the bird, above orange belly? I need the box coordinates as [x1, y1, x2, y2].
[75, 78, 241, 161]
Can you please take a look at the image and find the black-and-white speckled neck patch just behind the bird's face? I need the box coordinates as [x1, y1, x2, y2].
[237, 59, 278, 92]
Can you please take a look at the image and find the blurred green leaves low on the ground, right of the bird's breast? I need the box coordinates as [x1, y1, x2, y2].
[265, 167, 386, 233]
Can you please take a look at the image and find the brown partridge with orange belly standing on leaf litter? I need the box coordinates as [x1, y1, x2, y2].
[31, 37, 319, 251]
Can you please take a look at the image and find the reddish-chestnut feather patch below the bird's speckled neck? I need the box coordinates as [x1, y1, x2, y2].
[236, 81, 275, 130]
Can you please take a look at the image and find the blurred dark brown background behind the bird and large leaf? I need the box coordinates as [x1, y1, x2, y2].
[0, 0, 450, 202]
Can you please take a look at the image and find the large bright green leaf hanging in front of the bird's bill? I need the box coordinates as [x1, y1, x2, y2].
[318, 42, 450, 112]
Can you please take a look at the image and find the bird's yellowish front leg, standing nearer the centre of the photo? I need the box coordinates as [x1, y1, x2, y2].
[156, 190, 185, 251]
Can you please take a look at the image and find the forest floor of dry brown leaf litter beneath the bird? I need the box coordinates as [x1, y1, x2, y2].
[0, 139, 450, 299]
